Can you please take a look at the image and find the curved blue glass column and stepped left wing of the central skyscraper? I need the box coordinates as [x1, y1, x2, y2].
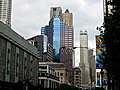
[41, 17, 62, 62]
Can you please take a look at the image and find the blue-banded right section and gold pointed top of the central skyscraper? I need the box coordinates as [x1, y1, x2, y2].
[61, 9, 74, 48]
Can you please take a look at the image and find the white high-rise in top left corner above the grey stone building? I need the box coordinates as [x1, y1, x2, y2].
[0, 0, 12, 27]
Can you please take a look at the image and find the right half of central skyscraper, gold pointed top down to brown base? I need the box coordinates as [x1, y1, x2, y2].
[60, 9, 74, 84]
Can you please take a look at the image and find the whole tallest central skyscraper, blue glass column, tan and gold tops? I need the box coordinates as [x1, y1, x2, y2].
[41, 7, 74, 83]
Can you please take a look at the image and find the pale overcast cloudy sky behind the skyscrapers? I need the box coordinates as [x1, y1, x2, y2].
[12, 0, 103, 66]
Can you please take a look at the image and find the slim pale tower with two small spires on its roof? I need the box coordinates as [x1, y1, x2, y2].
[80, 31, 90, 88]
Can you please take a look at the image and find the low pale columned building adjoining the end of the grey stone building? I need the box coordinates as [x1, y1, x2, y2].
[39, 62, 59, 90]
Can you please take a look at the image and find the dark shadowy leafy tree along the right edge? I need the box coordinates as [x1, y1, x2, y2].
[103, 0, 120, 90]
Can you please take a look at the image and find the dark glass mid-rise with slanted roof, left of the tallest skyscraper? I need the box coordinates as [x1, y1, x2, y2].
[27, 35, 52, 62]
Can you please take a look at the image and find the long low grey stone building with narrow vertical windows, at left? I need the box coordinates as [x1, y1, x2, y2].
[0, 22, 38, 85]
